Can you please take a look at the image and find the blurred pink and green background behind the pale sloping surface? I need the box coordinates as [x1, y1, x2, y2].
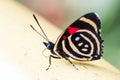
[17, 0, 120, 69]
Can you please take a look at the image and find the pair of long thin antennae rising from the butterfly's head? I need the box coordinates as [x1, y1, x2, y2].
[30, 14, 49, 42]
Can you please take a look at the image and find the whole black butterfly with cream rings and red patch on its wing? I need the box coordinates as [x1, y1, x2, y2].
[30, 13, 103, 70]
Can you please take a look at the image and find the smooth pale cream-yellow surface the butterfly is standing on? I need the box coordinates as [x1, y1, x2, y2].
[0, 0, 120, 80]
